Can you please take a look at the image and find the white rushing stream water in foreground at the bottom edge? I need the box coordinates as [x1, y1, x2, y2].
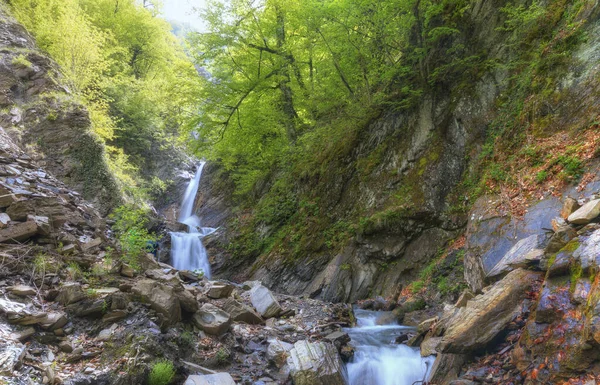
[345, 309, 434, 385]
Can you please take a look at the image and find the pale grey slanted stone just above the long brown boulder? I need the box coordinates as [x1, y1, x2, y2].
[487, 234, 547, 278]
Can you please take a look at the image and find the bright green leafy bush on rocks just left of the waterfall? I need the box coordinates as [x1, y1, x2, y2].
[111, 205, 156, 270]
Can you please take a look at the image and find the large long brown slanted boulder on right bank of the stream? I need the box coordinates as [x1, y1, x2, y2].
[438, 269, 540, 353]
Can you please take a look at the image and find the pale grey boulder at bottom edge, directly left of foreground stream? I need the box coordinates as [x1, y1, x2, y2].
[287, 340, 348, 385]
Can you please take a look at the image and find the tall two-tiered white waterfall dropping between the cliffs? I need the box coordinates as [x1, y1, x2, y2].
[171, 162, 215, 278]
